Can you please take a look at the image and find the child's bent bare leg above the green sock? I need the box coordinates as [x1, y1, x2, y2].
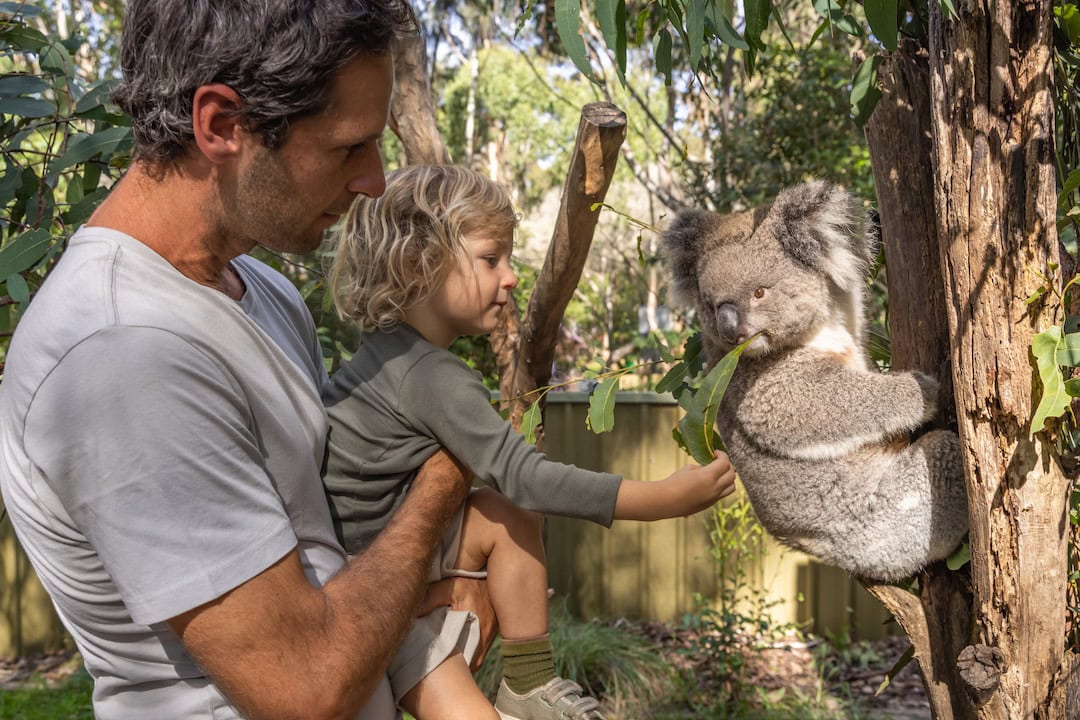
[457, 488, 548, 641]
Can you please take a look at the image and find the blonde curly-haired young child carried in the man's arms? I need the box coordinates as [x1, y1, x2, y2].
[325, 165, 734, 720]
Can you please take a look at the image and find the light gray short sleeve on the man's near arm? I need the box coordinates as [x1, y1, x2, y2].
[25, 327, 297, 625]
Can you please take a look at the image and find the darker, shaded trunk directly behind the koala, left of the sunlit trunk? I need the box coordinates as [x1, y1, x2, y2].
[866, 42, 974, 720]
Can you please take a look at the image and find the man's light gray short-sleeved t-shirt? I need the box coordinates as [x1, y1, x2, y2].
[0, 228, 392, 720]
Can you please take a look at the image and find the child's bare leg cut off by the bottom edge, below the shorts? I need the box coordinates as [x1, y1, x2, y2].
[402, 653, 499, 720]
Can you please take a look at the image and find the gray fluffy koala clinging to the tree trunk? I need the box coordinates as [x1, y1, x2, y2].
[662, 180, 968, 582]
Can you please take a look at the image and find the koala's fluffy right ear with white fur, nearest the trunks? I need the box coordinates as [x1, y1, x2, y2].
[769, 180, 877, 288]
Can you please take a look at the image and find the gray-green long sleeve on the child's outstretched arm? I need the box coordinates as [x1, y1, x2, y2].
[401, 353, 622, 526]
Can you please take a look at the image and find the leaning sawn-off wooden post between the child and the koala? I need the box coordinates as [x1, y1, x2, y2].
[491, 103, 626, 444]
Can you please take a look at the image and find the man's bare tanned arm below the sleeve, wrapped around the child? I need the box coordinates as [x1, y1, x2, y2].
[168, 451, 470, 719]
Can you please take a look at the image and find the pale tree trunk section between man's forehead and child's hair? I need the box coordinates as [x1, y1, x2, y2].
[390, 35, 450, 165]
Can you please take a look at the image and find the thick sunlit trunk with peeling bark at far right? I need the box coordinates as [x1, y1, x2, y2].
[930, 0, 1069, 719]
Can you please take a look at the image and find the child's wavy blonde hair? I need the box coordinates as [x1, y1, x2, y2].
[329, 165, 517, 331]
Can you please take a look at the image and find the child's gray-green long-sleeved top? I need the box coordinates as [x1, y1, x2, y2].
[324, 324, 622, 553]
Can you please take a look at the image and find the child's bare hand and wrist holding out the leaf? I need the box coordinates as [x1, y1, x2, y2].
[615, 452, 735, 520]
